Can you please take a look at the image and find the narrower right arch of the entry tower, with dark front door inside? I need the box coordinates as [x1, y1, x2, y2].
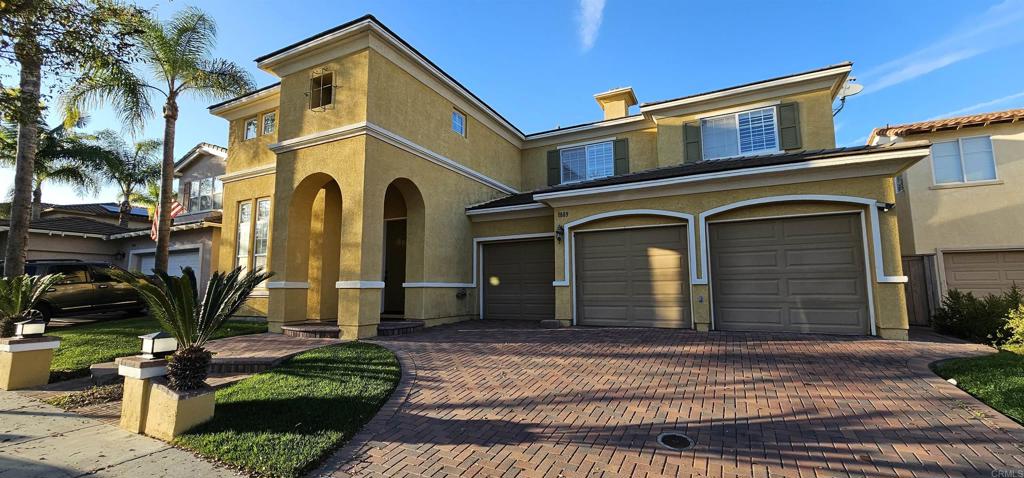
[381, 178, 425, 319]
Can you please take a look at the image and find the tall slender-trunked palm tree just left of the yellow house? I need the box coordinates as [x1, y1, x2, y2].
[63, 7, 254, 270]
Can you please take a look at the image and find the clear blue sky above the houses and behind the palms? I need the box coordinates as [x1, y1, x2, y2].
[0, 0, 1024, 203]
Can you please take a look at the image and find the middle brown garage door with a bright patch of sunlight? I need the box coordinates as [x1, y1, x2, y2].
[575, 226, 690, 328]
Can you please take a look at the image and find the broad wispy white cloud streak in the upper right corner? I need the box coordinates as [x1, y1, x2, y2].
[860, 0, 1024, 94]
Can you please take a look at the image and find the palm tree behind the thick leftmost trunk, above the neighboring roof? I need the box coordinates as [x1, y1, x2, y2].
[0, 117, 103, 220]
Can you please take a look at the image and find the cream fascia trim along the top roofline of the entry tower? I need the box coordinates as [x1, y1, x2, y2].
[256, 18, 526, 141]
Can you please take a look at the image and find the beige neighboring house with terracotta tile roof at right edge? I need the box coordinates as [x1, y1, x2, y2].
[868, 108, 1024, 322]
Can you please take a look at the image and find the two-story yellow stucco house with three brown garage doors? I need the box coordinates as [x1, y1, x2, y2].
[211, 15, 928, 339]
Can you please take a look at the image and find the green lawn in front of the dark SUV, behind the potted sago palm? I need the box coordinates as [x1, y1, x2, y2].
[46, 317, 266, 382]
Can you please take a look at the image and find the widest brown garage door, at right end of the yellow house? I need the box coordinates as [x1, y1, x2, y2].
[709, 214, 870, 335]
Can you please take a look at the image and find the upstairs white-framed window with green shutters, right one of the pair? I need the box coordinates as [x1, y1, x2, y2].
[700, 106, 778, 160]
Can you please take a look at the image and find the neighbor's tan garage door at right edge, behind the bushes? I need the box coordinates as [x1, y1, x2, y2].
[942, 251, 1024, 296]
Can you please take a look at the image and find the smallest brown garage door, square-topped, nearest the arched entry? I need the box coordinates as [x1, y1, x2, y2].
[483, 240, 555, 320]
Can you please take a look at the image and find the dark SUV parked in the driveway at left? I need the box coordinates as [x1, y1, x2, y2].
[18, 259, 145, 321]
